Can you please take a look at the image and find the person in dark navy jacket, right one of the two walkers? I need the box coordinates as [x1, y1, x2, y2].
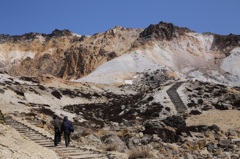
[61, 116, 74, 147]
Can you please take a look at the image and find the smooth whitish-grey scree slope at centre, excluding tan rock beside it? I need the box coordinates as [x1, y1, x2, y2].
[76, 46, 171, 84]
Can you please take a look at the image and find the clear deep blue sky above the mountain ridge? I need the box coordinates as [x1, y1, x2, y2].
[0, 0, 240, 35]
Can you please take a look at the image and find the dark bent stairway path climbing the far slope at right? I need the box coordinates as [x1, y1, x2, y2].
[167, 82, 187, 113]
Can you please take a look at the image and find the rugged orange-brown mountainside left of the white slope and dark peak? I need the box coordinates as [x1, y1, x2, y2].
[0, 27, 141, 79]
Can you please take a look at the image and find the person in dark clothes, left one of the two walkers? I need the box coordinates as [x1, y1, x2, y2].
[52, 115, 61, 146]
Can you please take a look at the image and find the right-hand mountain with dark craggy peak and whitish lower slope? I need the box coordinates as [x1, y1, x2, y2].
[77, 22, 240, 85]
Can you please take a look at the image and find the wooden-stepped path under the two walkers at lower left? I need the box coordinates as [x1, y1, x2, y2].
[6, 117, 108, 159]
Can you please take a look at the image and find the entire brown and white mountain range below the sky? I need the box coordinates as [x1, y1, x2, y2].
[0, 22, 240, 85]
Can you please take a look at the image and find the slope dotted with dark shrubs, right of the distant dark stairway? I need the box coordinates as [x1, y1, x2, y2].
[186, 81, 240, 113]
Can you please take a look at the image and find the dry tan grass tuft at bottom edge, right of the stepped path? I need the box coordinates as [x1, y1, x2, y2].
[128, 146, 154, 159]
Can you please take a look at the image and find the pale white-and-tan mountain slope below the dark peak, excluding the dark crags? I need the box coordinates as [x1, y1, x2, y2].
[76, 32, 240, 85]
